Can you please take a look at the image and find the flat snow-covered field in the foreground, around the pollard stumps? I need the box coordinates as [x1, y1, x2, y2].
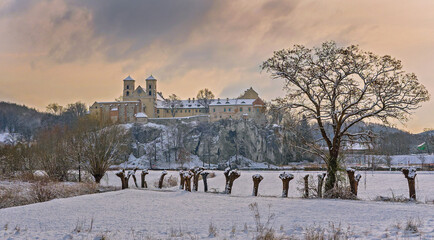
[0, 171, 434, 239]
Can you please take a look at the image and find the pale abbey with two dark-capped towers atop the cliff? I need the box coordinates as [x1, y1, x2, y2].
[90, 75, 265, 123]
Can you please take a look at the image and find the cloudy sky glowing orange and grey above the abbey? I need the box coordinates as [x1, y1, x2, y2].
[0, 0, 434, 132]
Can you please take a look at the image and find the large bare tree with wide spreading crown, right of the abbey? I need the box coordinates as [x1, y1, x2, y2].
[261, 42, 429, 190]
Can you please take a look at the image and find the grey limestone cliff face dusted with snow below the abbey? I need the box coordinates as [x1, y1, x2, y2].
[125, 120, 302, 168]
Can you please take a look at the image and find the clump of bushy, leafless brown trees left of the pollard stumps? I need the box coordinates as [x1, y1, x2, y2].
[0, 116, 130, 183]
